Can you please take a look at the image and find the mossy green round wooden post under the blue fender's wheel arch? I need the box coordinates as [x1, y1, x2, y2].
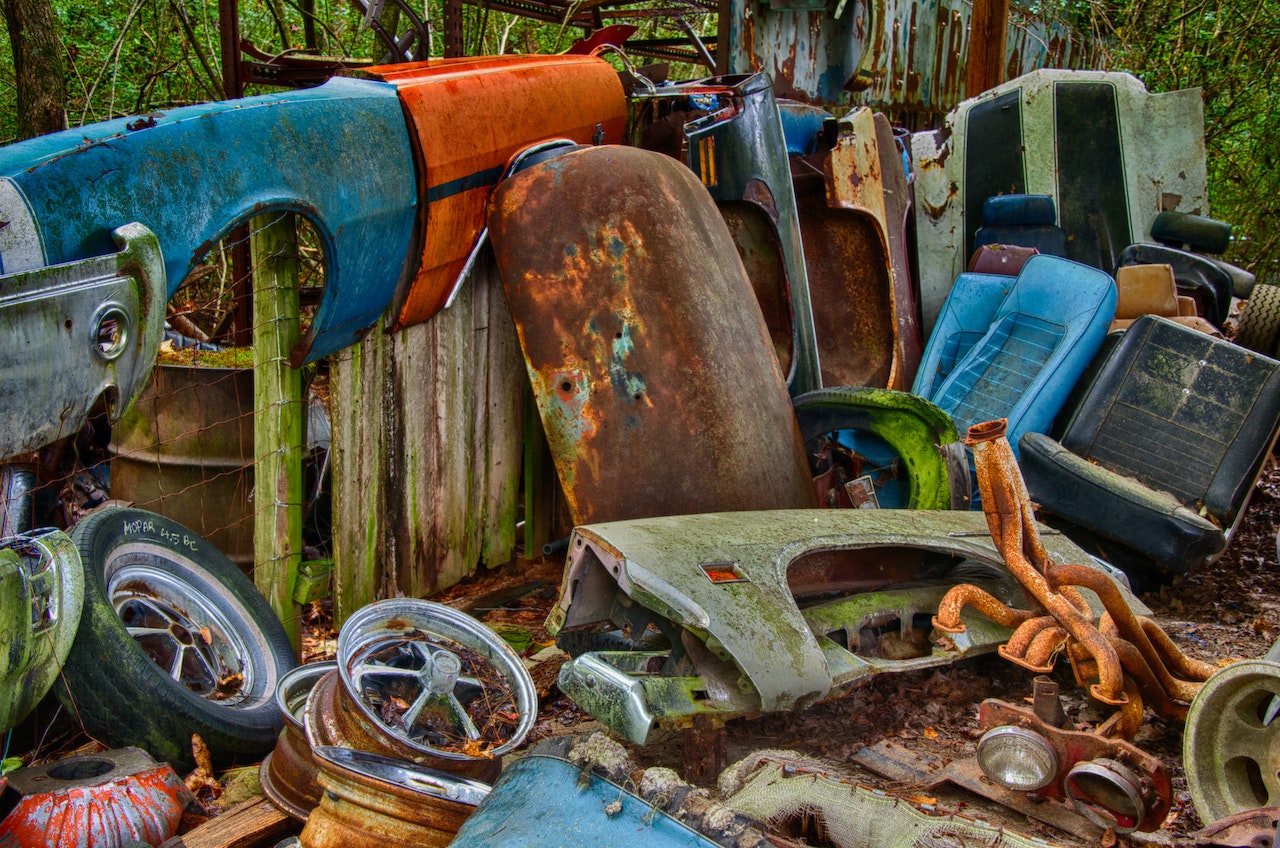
[251, 213, 306, 652]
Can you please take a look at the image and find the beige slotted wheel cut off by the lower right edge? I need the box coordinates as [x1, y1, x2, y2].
[1183, 655, 1280, 821]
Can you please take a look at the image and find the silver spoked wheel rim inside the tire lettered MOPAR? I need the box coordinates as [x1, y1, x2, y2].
[106, 553, 255, 707]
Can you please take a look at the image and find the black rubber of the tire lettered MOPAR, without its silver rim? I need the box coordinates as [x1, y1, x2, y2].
[56, 509, 296, 771]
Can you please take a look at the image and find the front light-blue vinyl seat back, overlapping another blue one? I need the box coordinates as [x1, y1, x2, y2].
[922, 254, 1116, 452]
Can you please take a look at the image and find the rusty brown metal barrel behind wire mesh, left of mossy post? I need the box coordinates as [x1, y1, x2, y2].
[110, 364, 253, 574]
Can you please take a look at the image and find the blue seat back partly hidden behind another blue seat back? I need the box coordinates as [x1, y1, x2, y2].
[911, 273, 1014, 397]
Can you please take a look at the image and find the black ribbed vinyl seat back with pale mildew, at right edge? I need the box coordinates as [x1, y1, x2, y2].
[1061, 315, 1280, 528]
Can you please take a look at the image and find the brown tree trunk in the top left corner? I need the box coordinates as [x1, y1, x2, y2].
[4, 0, 67, 140]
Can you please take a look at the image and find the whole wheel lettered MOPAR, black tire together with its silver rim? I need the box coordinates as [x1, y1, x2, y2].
[58, 509, 294, 770]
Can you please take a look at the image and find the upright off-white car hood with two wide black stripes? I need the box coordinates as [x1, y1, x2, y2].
[911, 70, 1208, 332]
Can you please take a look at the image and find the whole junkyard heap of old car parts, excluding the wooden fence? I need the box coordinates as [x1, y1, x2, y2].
[0, 43, 1280, 848]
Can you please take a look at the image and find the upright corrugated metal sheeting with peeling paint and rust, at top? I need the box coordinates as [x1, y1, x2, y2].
[721, 0, 1091, 111]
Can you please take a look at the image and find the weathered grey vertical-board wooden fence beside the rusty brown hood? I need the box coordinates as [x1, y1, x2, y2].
[330, 252, 527, 623]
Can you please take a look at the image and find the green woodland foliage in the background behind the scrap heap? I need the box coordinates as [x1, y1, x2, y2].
[0, 0, 1280, 275]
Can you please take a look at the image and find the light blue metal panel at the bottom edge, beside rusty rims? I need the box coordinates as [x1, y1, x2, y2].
[449, 753, 718, 848]
